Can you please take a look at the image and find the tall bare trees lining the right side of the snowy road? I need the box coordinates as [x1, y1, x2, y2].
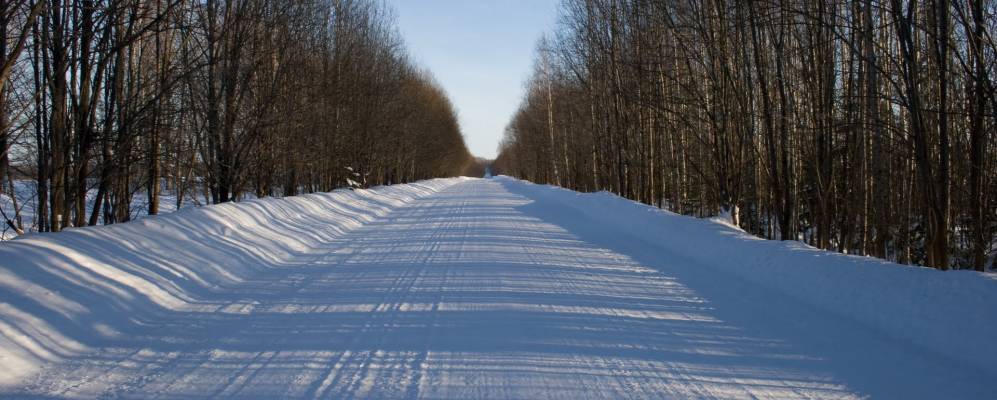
[495, 0, 997, 270]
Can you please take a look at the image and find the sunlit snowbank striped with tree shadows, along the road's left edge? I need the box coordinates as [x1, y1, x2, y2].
[0, 179, 461, 387]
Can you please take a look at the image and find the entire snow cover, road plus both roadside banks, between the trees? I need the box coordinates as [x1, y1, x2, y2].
[0, 177, 997, 399]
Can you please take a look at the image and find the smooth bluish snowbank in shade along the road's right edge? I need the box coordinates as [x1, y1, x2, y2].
[497, 177, 997, 369]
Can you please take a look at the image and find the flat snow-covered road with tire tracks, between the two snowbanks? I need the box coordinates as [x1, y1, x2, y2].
[0, 178, 997, 400]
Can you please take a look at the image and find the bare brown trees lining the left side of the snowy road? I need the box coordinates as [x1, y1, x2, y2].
[0, 0, 472, 231]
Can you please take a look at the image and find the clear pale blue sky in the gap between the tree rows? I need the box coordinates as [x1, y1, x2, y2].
[388, 0, 559, 158]
